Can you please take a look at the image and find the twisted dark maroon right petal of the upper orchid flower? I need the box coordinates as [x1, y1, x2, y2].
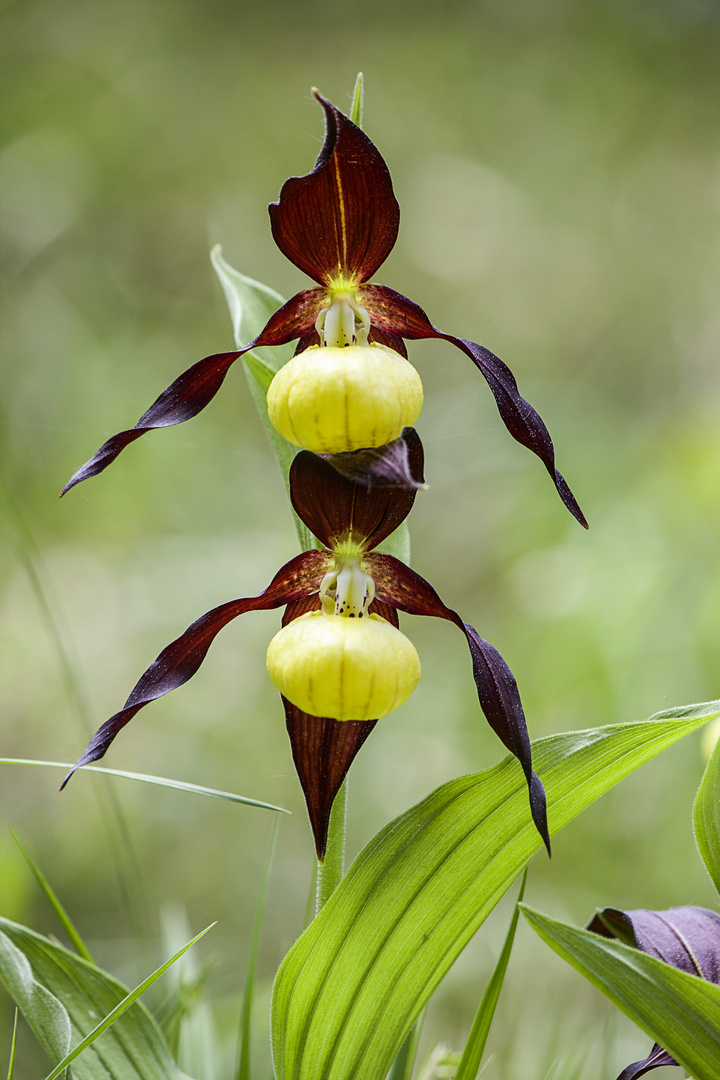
[359, 285, 587, 528]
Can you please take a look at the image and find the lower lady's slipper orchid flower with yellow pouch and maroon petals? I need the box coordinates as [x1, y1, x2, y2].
[64, 429, 549, 858]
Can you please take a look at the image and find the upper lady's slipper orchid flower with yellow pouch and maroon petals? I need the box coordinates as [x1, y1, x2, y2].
[63, 91, 587, 527]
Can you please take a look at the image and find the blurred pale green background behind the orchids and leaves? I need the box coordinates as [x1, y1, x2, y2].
[0, 0, 720, 1080]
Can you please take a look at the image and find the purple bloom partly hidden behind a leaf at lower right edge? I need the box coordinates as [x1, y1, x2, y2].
[587, 907, 720, 1080]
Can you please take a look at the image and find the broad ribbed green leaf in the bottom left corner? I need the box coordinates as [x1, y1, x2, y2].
[0, 918, 191, 1080]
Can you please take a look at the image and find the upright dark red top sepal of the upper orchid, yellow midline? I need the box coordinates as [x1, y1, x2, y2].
[268, 91, 399, 285]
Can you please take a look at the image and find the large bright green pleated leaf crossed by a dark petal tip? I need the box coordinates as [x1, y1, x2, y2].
[272, 702, 720, 1080]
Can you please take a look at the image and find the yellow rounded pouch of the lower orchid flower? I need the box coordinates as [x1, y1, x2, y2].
[268, 611, 420, 720]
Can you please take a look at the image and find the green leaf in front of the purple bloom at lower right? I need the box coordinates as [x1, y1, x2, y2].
[522, 906, 720, 1080]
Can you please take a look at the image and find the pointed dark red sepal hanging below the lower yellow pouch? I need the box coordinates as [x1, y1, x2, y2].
[283, 698, 378, 860]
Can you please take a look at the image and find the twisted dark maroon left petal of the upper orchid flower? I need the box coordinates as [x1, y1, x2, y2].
[60, 288, 324, 496]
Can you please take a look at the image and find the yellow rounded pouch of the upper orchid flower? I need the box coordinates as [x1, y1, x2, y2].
[268, 343, 422, 454]
